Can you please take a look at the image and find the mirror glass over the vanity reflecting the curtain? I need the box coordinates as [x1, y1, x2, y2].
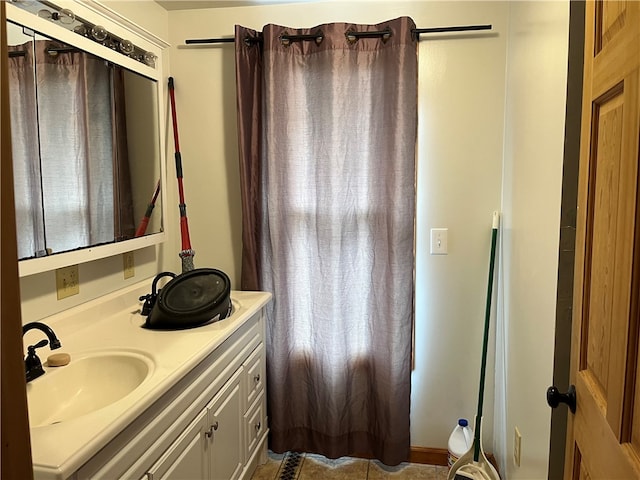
[7, 4, 163, 278]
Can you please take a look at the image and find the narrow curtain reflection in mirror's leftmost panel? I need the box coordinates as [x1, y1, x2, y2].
[7, 42, 45, 258]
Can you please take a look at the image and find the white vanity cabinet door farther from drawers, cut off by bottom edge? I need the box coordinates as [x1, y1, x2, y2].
[147, 409, 210, 480]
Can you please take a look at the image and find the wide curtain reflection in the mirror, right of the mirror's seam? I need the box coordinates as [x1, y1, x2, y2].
[7, 41, 135, 258]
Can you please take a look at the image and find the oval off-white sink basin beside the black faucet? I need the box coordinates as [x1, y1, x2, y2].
[27, 351, 153, 428]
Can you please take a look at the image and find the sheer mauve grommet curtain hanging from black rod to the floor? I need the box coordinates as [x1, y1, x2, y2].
[236, 17, 417, 465]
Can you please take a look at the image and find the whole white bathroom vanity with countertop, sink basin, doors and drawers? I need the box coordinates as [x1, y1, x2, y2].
[25, 281, 271, 480]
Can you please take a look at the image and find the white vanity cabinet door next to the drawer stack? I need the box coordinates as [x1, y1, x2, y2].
[205, 368, 243, 480]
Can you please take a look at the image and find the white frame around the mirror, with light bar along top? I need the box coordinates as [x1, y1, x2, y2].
[6, 0, 169, 277]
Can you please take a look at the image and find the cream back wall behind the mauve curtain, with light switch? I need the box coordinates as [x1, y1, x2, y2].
[169, 1, 508, 450]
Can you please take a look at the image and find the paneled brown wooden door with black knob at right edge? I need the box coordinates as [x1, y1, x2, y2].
[565, 1, 640, 480]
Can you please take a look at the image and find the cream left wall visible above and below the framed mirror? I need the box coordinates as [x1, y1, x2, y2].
[20, 0, 170, 324]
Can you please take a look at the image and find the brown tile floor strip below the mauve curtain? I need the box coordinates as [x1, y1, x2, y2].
[251, 452, 448, 480]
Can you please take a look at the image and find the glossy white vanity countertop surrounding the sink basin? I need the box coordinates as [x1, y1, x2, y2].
[25, 280, 271, 479]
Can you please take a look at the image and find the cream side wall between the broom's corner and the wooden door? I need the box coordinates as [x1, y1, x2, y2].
[496, 1, 569, 480]
